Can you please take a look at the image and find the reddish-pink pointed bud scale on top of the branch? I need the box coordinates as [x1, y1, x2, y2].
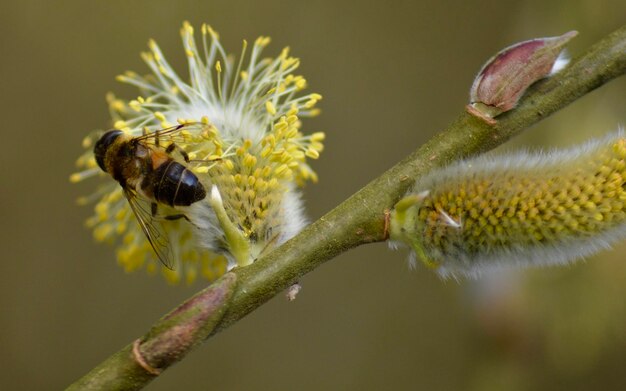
[468, 31, 578, 118]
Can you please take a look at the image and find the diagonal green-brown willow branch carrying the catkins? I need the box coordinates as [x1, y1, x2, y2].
[69, 26, 626, 390]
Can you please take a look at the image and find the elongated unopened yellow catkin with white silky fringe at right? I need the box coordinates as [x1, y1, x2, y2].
[390, 132, 626, 277]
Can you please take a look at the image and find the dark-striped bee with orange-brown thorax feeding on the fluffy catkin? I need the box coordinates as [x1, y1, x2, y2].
[94, 124, 206, 269]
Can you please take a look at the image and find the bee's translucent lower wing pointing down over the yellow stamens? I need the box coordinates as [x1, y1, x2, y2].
[124, 189, 174, 270]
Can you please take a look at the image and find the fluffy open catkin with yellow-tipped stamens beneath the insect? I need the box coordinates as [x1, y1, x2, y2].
[75, 22, 323, 283]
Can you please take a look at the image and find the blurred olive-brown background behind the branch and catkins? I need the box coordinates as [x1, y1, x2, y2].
[0, 0, 626, 390]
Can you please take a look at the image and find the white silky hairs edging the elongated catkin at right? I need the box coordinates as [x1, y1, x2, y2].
[389, 128, 626, 279]
